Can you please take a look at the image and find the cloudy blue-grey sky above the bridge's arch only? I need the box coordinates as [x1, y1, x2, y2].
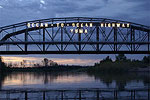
[0, 0, 149, 26]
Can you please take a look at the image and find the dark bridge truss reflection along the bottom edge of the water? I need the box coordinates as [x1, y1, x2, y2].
[0, 89, 150, 100]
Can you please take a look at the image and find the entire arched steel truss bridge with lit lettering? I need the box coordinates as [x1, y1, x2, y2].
[0, 17, 150, 54]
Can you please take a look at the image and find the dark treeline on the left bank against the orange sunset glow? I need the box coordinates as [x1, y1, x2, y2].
[0, 57, 85, 73]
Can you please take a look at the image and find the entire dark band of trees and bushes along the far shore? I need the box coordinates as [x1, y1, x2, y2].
[0, 54, 150, 73]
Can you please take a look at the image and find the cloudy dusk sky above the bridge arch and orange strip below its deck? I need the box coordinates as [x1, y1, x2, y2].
[0, 0, 150, 65]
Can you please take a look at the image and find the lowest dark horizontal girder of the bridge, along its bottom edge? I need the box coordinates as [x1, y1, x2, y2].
[0, 51, 150, 55]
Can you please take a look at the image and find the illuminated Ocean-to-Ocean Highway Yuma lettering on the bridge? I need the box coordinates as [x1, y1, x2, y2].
[27, 22, 130, 33]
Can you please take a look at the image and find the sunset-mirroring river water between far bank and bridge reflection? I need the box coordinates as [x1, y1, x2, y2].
[0, 72, 150, 89]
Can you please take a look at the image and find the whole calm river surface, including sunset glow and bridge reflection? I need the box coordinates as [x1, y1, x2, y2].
[0, 72, 150, 100]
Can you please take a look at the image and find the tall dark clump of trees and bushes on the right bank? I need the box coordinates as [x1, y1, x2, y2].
[88, 54, 150, 73]
